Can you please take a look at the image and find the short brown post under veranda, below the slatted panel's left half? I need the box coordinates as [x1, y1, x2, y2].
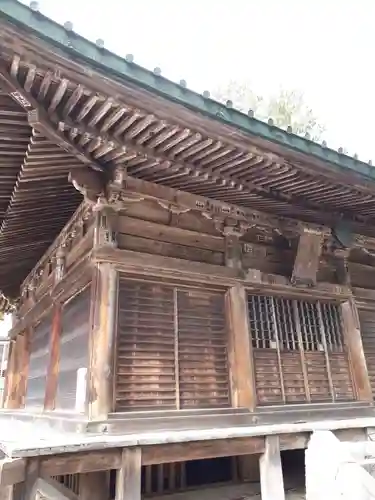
[116, 448, 142, 500]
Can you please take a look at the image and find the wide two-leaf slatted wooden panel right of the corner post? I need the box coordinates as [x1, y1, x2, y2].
[116, 279, 229, 411]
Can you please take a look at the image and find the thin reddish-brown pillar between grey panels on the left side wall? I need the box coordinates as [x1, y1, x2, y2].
[44, 304, 62, 410]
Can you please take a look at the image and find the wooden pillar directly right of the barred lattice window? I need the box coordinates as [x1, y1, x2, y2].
[341, 298, 373, 402]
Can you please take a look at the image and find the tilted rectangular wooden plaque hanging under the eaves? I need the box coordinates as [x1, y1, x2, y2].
[292, 228, 323, 286]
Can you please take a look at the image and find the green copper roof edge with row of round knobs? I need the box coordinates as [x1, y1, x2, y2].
[0, 0, 375, 181]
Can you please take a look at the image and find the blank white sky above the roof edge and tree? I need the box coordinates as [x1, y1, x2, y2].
[19, 0, 375, 163]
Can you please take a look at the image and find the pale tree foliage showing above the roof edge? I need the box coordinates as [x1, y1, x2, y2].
[212, 80, 325, 141]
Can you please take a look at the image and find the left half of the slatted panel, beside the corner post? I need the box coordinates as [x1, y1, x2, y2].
[116, 280, 176, 411]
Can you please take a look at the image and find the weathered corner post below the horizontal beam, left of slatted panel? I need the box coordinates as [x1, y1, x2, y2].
[88, 263, 118, 420]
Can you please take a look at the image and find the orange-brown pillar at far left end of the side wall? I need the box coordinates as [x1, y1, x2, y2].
[4, 331, 30, 409]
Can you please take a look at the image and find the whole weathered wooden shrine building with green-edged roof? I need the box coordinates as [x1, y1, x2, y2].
[0, 0, 375, 500]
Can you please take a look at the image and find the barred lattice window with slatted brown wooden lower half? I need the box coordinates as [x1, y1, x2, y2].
[248, 295, 354, 404]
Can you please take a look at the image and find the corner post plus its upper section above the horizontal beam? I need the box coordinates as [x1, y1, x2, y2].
[88, 197, 118, 420]
